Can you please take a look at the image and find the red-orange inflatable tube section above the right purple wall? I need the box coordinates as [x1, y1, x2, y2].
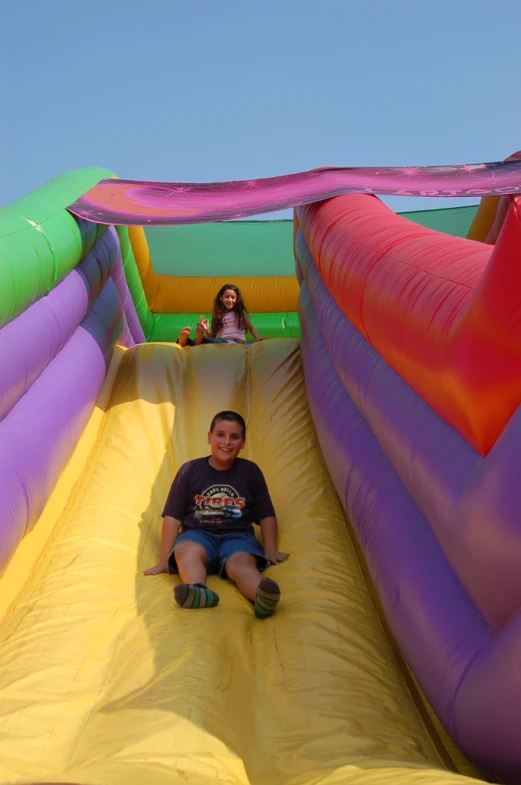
[298, 194, 521, 455]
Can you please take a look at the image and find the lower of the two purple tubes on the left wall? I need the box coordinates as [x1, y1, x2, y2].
[0, 281, 121, 574]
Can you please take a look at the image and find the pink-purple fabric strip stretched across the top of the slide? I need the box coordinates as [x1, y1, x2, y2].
[69, 160, 521, 225]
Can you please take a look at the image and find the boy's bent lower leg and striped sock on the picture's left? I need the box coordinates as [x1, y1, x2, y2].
[174, 541, 219, 608]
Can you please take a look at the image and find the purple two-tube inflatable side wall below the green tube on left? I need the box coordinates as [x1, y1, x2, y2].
[0, 220, 144, 573]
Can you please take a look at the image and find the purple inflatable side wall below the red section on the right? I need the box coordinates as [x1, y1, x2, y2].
[296, 225, 521, 781]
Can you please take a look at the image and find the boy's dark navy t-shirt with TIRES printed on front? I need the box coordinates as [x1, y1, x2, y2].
[163, 458, 275, 534]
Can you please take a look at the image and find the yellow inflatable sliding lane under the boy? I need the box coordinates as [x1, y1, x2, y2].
[0, 339, 480, 785]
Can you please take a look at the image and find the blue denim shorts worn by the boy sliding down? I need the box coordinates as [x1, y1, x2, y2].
[168, 530, 268, 578]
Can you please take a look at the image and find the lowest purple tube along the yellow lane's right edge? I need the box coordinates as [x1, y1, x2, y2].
[299, 274, 521, 783]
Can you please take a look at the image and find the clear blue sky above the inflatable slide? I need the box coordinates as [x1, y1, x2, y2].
[0, 0, 521, 217]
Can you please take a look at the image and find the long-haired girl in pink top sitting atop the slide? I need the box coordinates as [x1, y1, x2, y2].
[177, 283, 266, 346]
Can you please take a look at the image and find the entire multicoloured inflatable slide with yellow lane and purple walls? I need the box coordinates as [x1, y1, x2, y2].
[0, 156, 521, 785]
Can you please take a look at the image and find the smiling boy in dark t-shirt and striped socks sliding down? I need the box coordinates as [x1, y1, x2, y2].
[145, 411, 288, 619]
